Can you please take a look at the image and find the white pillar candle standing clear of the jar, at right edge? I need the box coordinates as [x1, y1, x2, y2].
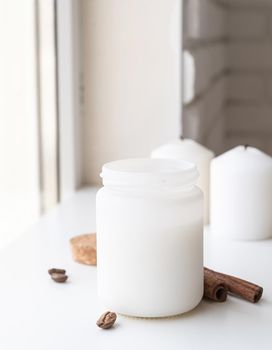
[210, 146, 272, 240]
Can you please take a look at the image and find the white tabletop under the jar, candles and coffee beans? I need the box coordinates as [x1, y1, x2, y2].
[0, 189, 272, 350]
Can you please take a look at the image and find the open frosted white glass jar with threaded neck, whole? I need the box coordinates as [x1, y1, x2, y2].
[97, 159, 203, 317]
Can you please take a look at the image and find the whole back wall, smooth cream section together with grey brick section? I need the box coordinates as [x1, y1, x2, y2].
[78, 0, 272, 183]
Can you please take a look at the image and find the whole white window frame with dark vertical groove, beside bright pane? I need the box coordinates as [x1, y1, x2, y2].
[35, 0, 83, 213]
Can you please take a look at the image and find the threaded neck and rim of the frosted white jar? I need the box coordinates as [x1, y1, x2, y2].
[100, 158, 198, 187]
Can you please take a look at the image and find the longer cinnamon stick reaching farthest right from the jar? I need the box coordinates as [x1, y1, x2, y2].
[204, 267, 263, 303]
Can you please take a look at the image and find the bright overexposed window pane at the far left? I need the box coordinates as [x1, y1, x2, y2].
[0, 0, 40, 252]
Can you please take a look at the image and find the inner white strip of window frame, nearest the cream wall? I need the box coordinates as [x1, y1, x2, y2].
[55, 0, 84, 200]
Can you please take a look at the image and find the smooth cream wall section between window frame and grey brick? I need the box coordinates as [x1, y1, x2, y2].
[82, 0, 182, 184]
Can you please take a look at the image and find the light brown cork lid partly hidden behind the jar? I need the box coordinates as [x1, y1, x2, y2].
[70, 233, 96, 266]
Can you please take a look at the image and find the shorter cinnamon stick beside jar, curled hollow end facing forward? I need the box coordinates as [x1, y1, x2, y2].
[204, 268, 228, 302]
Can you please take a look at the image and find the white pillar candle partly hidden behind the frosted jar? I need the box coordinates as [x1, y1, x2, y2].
[151, 139, 214, 224]
